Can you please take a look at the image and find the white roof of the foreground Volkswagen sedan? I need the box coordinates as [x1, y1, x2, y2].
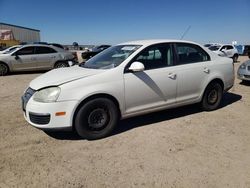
[119, 39, 202, 46]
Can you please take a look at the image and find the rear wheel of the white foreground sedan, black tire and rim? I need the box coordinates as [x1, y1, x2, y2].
[201, 82, 223, 111]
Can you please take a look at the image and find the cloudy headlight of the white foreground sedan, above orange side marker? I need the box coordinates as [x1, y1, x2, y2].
[33, 87, 61, 103]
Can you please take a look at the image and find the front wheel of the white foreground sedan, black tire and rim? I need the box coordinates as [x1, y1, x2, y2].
[74, 98, 119, 140]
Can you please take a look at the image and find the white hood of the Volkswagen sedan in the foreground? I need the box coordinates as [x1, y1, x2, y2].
[30, 65, 106, 90]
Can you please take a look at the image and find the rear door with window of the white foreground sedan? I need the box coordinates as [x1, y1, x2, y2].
[175, 43, 210, 103]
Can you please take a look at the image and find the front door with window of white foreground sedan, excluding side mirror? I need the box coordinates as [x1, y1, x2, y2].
[124, 44, 177, 114]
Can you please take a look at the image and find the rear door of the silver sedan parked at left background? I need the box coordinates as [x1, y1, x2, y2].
[35, 46, 57, 70]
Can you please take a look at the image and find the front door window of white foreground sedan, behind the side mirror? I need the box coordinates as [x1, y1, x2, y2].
[134, 44, 173, 70]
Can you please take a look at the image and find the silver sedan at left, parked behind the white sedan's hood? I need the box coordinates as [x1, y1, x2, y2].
[0, 44, 74, 76]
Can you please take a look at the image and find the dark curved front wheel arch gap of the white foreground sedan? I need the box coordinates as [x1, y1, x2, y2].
[71, 93, 121, 130]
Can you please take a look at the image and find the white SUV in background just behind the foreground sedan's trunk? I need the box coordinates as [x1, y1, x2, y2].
[208, 44, 239, 62]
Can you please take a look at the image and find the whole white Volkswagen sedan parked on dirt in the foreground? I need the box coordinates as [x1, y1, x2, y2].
[22, 40, 234, 139]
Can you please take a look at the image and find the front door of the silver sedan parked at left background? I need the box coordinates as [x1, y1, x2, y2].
[10, 46, 36, 71]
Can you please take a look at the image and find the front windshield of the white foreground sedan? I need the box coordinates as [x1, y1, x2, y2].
[80, 45, 141, 69]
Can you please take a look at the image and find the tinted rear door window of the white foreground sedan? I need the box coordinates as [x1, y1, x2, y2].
[176, 43, 210, 64]
